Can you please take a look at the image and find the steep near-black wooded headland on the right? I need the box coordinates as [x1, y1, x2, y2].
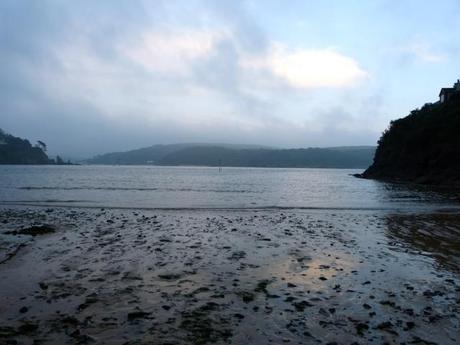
[362, 92, 460, 185]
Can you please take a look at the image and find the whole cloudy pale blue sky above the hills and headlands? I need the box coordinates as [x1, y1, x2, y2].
[0, 0, 460, 158]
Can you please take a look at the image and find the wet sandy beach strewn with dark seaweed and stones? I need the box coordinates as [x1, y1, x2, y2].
[0, 207, 460, 344]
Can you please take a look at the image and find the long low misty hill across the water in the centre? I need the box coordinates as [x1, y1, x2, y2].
[87, 144, 375, 168]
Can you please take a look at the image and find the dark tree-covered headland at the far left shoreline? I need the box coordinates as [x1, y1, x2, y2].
[0, 129, 50, 164]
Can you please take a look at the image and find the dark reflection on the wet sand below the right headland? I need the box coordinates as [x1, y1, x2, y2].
[386, 214, 460, 272]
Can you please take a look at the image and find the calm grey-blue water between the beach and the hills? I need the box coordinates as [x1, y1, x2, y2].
[0, 166, 460, 211]
